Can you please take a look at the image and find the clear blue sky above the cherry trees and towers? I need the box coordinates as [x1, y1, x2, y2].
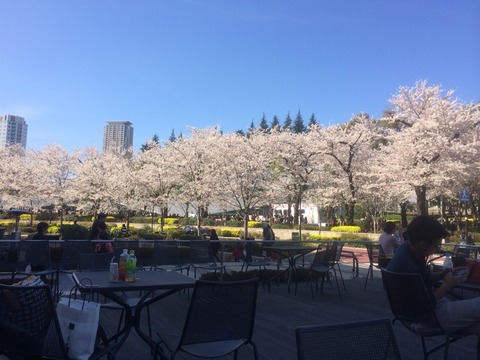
[0, 0, 480, 150]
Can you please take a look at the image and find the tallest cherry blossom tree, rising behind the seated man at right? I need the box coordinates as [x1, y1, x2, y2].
[383, 81, 478, 214]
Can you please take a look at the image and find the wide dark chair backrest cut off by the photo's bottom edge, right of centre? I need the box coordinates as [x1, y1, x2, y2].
[295, 319, 401, 360]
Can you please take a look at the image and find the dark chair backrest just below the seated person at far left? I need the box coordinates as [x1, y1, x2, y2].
[16, 240, 52, 271]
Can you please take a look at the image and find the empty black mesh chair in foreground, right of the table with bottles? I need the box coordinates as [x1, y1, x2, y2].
[170, 279, 258, 359]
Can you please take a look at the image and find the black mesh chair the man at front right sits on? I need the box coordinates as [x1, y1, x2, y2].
[381, 269, 480, 359]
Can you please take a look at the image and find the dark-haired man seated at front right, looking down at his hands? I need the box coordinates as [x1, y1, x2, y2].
[387, 216, 480, 335]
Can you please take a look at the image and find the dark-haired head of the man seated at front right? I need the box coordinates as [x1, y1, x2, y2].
[407, 215, 449, 255]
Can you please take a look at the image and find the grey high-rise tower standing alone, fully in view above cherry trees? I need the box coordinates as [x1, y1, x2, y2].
[103, 121, 133, 152]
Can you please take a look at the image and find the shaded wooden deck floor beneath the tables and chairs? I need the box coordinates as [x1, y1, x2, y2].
[84, 263, 476, 360]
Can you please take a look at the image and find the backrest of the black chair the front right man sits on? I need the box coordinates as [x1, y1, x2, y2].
[381, 269, 443, 331]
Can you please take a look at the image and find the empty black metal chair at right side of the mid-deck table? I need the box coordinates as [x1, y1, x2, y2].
[295, 241, 346, 300]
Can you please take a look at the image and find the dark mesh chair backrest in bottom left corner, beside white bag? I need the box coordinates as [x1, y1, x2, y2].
[0, 285, 68, 359]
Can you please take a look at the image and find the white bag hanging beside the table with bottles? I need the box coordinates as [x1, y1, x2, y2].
[57, 298, 100, 360]
